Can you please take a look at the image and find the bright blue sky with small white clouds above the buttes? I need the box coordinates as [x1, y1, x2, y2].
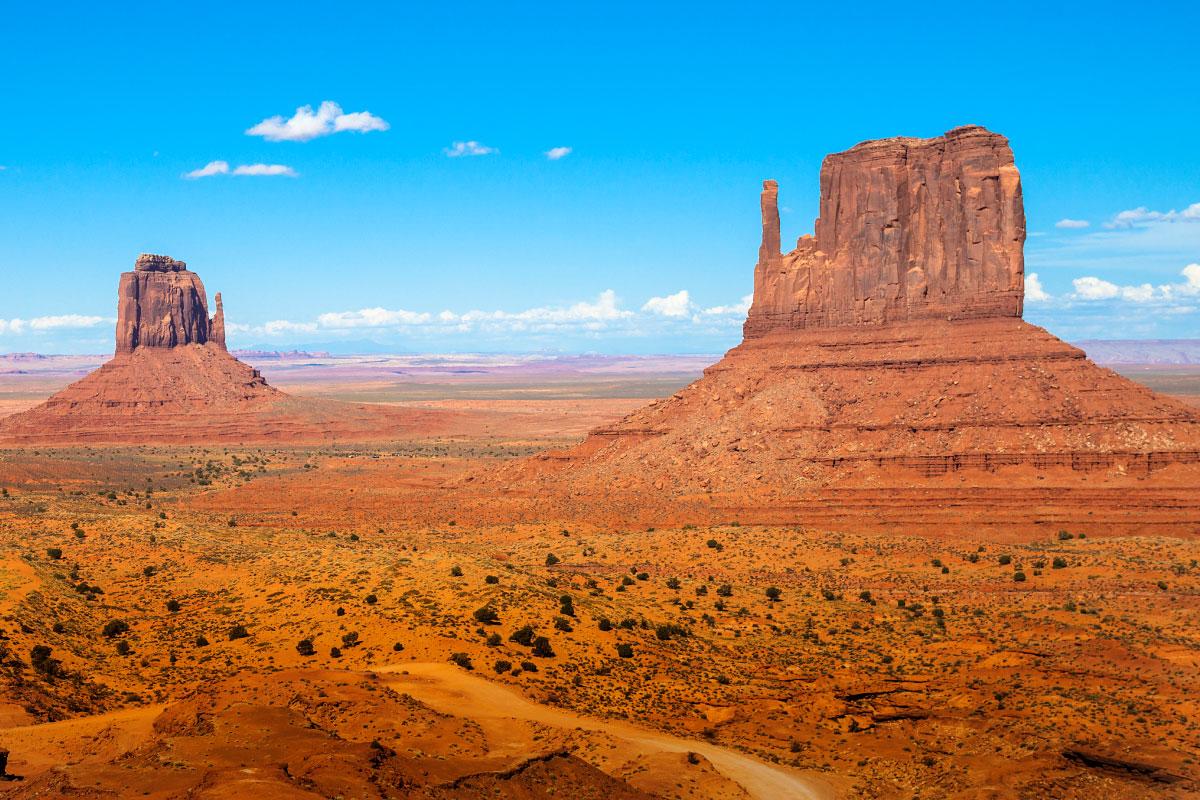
[0, 2, 1200, 353]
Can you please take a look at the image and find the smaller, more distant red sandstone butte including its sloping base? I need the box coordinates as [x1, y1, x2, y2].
[0, 254, 444, 445]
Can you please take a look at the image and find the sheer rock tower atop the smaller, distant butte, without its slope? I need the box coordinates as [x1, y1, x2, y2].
[116, 253, 216, 353]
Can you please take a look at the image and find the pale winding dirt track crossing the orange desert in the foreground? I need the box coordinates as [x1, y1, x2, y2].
[374, 663, 835, 800]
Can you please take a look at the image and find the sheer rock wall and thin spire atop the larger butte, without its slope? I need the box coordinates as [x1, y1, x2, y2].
[744, 126, 1025, 338]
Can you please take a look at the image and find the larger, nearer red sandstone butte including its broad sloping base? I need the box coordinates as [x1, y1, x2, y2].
[492, 126, 1200, 532]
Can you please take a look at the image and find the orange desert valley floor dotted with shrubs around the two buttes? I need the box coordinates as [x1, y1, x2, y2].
[0, 356, 1200, 799]
